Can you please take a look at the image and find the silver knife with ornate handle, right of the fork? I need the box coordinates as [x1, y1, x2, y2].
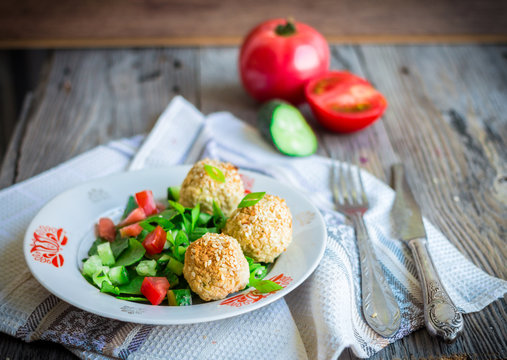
[391, 164, 463, 342]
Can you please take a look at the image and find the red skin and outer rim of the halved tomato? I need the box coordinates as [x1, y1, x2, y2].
[305, 71, 387, 133]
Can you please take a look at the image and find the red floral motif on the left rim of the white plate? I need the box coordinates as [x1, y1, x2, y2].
[30, 225, 67, 267]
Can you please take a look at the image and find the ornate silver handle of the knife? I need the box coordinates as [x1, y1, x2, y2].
[408, 238, 463, 343]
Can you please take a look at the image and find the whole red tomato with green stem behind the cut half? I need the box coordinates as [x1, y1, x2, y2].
[239, 19, 329, 104]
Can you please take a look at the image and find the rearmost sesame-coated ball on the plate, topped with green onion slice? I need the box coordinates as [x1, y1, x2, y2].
[179, 159, 245, 216]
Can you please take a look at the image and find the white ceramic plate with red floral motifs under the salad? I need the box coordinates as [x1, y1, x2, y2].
[23, 166, 326, 325]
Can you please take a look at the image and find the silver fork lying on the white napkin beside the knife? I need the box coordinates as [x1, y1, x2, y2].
[332, 159, 401, 337]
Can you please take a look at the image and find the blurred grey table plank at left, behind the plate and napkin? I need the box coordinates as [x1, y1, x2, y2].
[12, 49, 196, 181]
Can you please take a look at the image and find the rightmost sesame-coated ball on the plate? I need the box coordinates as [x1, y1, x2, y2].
[222, 194, 292, 263]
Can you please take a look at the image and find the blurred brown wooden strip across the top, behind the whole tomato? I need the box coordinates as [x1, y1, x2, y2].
[0, 0, 507, 47]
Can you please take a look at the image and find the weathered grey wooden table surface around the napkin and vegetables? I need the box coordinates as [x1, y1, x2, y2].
[0, 45, 507, 359]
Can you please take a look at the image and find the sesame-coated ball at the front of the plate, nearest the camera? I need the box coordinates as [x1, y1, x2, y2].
[183, 233, 250, 301]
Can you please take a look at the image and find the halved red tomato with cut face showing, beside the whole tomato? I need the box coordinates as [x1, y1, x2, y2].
[305, 71, 387, 132]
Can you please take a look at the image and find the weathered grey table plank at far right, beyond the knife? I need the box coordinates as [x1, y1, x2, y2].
[358, 46, 507, 359]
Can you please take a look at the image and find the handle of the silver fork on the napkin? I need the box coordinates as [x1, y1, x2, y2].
[352, 214, 401, 337]
